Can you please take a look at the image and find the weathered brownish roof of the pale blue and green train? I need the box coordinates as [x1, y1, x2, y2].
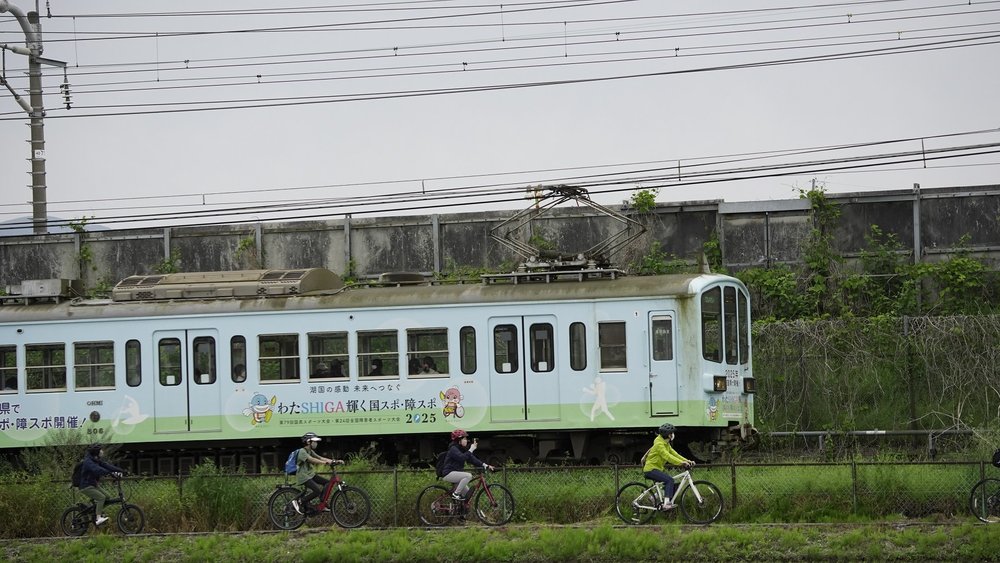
[0, 268, 742, 324]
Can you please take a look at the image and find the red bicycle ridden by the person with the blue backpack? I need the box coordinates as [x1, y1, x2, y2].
[267, 462, 372, 530]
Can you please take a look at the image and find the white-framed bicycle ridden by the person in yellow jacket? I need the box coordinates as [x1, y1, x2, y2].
[615, 469, 723, 524]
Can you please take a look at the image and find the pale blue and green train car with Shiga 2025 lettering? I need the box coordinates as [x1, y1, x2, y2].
[0, 268, 755, 474]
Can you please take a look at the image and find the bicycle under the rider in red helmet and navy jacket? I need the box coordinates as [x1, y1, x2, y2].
[417, 469, 514, 526]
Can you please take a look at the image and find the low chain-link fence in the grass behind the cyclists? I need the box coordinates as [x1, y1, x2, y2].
[0, 462, 1000, 538]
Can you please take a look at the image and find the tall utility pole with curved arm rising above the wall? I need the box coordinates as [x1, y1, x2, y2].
[0, 0, 66, 235]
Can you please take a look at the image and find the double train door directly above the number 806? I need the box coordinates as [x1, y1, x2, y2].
[153, 330, 222, 434]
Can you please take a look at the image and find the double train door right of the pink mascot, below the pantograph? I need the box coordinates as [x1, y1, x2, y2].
[489, 315, 560, 422]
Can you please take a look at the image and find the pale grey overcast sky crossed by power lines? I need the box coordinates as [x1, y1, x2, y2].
[0, 0, 1000, 234]
